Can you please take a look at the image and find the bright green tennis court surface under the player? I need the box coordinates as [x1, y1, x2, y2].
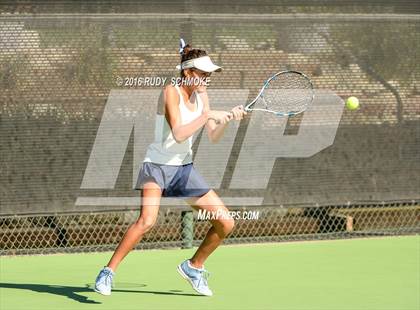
[0, 236, 420, 310]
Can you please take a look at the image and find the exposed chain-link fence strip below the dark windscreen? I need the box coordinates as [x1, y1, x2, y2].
[0, 201, 420, 255]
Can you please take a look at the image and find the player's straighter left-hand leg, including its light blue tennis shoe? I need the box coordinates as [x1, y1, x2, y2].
[95, 182, 162, 295]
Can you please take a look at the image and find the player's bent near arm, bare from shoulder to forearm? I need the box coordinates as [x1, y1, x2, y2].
[164, 85, 209, 143]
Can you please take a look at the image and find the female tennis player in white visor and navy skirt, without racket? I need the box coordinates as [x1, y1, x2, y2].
[95, 39, 246, 296]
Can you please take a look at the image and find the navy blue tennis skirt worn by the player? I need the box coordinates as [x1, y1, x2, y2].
[134, 162, 210, 198]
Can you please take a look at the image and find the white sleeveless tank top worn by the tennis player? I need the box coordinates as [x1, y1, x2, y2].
[143, 85, 203, 166]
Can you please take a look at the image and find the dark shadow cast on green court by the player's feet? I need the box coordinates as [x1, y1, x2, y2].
[0, 283, 202, 304]
